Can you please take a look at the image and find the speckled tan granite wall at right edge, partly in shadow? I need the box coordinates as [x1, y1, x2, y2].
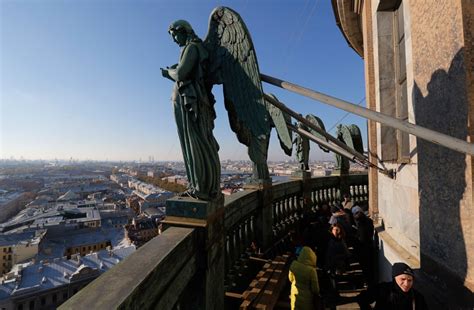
[409, 0, 474, 291]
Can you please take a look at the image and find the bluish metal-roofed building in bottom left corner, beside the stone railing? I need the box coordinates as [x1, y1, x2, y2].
[0, 245, 136, 310]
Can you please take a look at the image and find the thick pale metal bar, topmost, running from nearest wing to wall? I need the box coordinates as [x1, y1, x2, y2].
[260, 74, 474, 156]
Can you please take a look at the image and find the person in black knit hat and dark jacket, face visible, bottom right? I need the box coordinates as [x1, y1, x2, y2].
[357, 263, 428, 310]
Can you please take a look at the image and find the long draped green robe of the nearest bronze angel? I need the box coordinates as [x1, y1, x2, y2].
[168, 39, 221, 200]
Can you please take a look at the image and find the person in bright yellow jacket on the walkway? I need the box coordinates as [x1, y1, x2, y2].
[288, 246, 319, 310]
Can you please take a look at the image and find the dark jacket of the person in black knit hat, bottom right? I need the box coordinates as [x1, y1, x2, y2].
[357, 280, 428, 310]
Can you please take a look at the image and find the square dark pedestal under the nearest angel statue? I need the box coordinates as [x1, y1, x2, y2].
[163, 195, 225, 309]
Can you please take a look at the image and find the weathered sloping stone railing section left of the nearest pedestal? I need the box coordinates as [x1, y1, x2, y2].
[60, 228, 197, 310]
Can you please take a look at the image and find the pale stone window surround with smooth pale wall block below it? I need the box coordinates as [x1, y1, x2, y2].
[368, 0, 420, 267]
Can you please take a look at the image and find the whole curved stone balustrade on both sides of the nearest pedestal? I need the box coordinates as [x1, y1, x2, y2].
[61, 175, 368, 309]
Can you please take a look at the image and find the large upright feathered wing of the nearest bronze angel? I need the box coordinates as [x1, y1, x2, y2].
[204, 7, 271, 146]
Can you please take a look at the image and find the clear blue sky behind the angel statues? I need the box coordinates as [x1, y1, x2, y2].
[0, 0, 366, 160]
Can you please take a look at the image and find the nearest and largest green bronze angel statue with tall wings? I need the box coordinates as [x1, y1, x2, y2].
[161, 7, 291, 200]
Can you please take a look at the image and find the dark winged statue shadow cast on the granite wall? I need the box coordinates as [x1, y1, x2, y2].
[413, 48, 473, 306]
